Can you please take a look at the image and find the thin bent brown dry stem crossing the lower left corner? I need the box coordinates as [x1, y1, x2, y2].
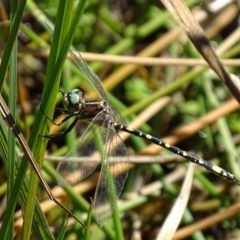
[0, 95, 86, 228]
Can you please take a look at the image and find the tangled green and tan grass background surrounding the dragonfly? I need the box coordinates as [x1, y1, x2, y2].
[0, 0, 240, 239]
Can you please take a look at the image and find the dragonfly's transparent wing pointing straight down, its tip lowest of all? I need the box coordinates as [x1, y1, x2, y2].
[93, 124, 128, 226]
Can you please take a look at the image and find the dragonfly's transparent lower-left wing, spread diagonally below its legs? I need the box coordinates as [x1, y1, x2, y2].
[57, 112, 106, 186]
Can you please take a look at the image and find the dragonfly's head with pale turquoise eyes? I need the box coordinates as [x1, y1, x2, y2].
[62, 89, 82, 112]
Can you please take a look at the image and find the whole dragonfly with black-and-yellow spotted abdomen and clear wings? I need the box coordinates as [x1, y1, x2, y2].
[43, 51, 240, 226]
